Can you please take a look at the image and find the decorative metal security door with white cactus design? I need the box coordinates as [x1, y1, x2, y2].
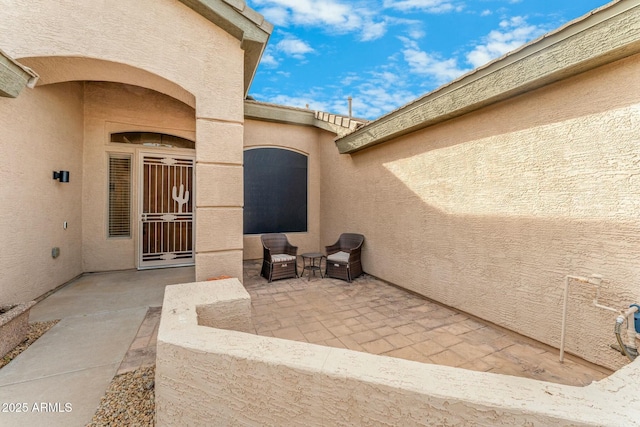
[139, 155, 194, 268]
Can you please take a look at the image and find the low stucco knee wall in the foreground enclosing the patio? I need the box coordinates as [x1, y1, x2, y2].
[155, 279, 640, 426]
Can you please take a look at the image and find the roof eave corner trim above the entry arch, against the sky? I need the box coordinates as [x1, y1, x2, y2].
[180, 0, 273, 96]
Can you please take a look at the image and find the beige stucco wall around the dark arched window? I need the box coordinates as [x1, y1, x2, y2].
[238, 120, 328, 259]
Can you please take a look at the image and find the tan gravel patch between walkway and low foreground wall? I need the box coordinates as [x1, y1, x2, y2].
[87, 366, 156, 427]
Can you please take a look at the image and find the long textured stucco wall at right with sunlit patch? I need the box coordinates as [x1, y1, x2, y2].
[321, 56, 640, 368]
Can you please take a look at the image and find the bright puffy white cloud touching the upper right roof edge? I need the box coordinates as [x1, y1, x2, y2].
[467, 16, 545, 68]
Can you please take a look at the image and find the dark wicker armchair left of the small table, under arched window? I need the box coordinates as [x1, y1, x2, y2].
[260, 233, 298, 282]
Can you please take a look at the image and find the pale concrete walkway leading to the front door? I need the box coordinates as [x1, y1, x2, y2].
[0, 267, 195, 427]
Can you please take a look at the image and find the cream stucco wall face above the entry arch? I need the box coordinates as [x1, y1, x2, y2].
[0, 0, 243, 117]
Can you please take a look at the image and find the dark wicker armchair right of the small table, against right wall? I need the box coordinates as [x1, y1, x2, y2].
[326, 233, 364, 283]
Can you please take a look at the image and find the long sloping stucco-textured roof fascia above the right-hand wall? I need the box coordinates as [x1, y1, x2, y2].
[336, 0, 640, 154]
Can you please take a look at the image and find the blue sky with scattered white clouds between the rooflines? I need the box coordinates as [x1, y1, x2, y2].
[247, 0, 608, 119]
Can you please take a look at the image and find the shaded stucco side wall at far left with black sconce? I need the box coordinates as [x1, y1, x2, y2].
[0, 83, 83, 304]
